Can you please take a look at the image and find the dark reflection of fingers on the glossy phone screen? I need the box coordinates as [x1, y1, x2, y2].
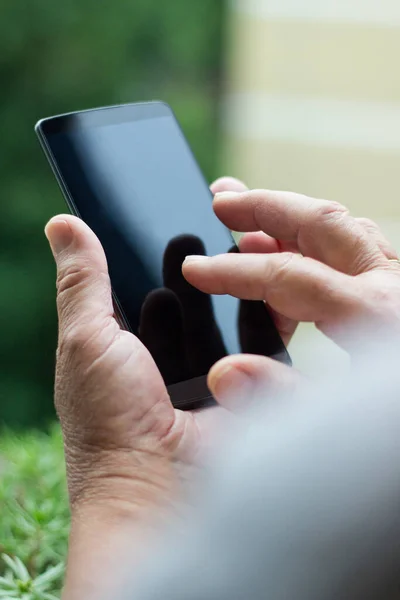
[140, 235, 227, 385]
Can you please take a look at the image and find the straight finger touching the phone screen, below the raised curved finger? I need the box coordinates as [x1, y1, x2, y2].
[183, 253, 360, 330]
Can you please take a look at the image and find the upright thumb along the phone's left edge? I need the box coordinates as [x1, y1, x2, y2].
[45, 215, 114, 337]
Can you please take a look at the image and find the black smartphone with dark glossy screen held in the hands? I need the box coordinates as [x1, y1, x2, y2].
[35, 102, 290, 409]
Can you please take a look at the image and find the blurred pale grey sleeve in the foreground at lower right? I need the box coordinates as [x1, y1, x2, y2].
[128, 346, 400, 600]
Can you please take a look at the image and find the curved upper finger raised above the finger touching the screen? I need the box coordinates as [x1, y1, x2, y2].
[214, 190, 387, 275]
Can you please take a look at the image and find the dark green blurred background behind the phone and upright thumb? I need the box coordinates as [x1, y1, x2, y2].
[0, 0, 225, 427]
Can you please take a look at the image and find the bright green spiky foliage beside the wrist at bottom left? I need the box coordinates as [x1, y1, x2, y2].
[0, 428, 69, 600]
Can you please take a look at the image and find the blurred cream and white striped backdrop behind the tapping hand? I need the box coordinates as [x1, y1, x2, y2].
[222, 0, 400, 372]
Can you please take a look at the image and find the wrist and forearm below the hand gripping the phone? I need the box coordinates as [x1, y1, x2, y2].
[63, 450, 177, 600]
